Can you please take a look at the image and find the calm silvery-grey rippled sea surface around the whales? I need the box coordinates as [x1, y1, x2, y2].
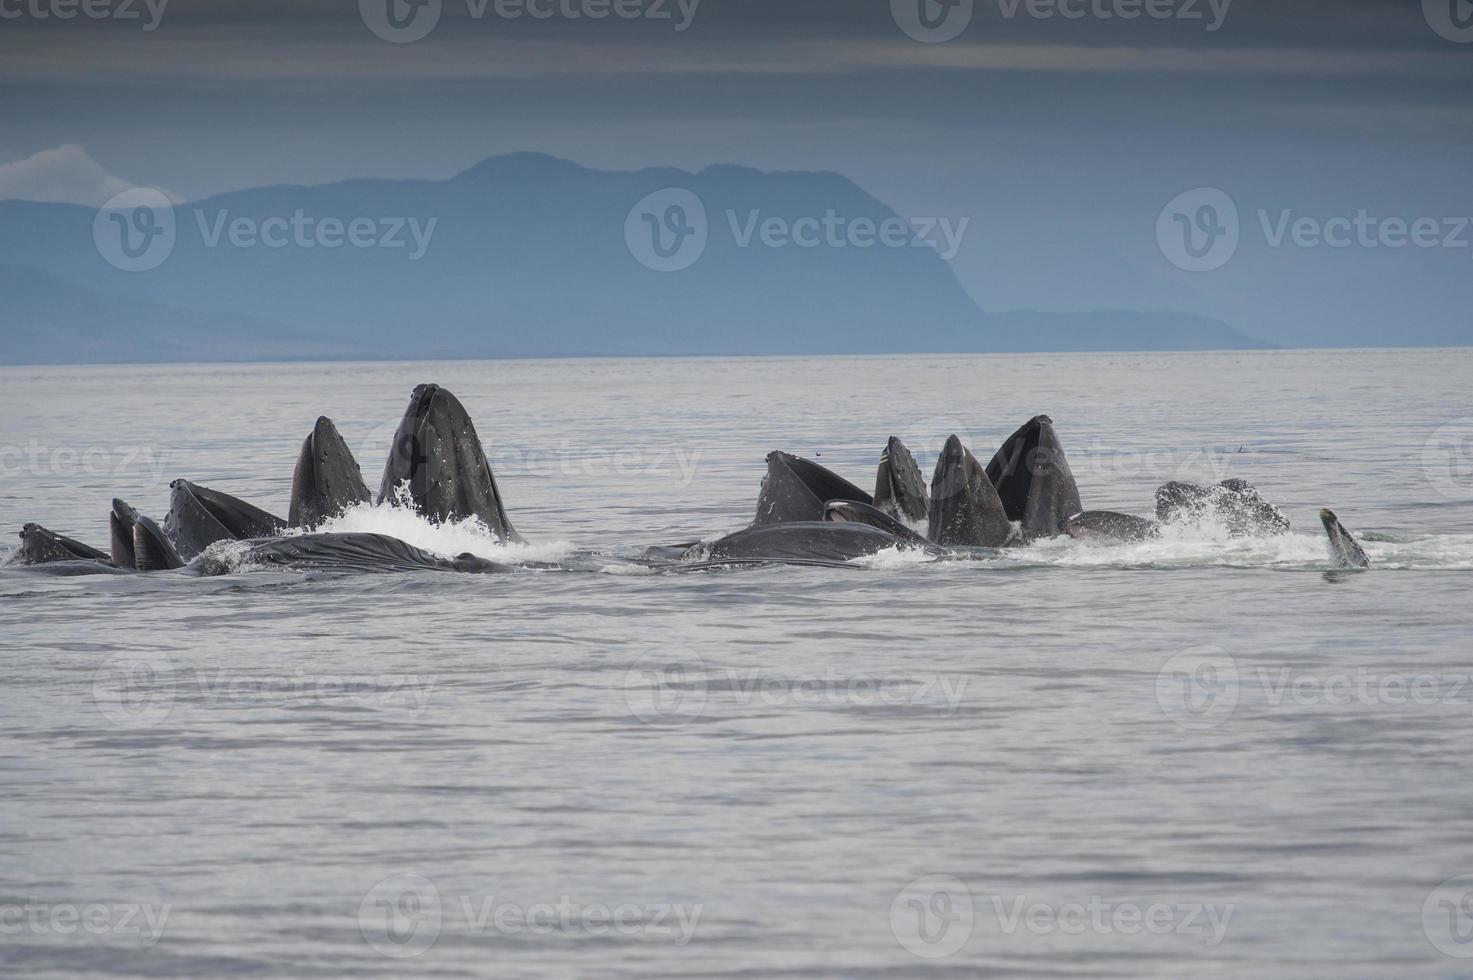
[0, 351, 1473, 977]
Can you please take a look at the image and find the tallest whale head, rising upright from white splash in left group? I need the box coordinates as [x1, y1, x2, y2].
[379, 385, 521, 542]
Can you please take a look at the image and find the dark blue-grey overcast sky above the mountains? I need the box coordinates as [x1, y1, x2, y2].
[0, 0, 1473, 343]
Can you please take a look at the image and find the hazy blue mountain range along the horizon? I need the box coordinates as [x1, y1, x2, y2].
[0, 153, 1267, 364]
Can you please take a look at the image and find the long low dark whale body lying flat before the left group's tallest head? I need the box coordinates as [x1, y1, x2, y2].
[191, 533, 516, 575]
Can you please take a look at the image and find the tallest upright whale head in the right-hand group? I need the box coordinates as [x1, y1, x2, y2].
[987, 416, 1084, 541]
